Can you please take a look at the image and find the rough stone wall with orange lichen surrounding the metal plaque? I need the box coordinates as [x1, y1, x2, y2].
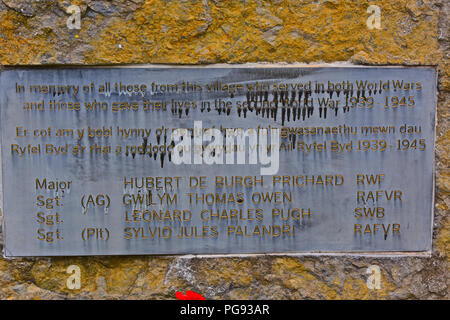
[0, 0, 450, 299]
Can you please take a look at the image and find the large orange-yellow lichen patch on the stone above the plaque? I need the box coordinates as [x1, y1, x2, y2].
[87, 0, 443, 64]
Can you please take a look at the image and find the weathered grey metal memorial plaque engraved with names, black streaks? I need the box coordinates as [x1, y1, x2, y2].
[0, 67, 436, 257]
